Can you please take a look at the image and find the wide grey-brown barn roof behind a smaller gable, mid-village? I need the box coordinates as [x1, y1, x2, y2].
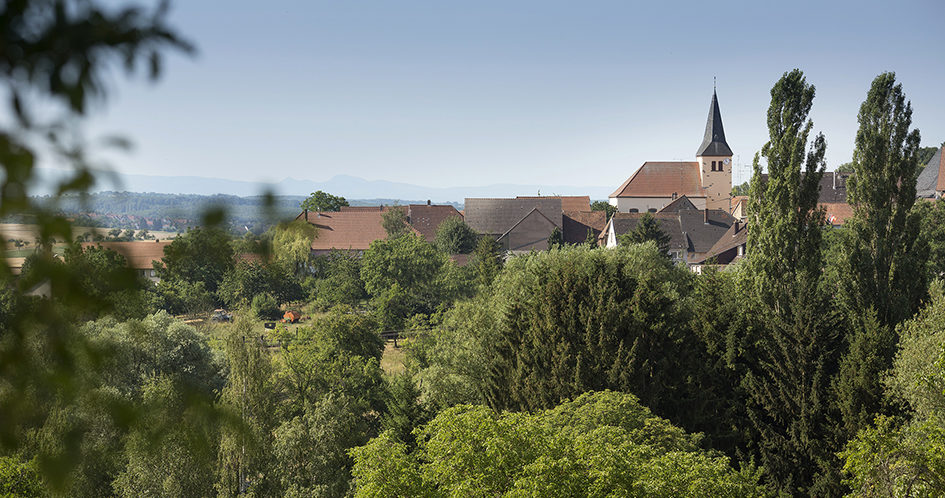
[463, 197, 561, 236]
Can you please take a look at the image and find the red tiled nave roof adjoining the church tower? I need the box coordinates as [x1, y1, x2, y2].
[610, 161, 705, 197]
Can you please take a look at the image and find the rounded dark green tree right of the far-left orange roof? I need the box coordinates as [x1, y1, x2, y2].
[154, 227, 233, 292]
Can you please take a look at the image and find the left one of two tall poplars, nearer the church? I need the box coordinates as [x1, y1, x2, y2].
[743, 69, 838, 496]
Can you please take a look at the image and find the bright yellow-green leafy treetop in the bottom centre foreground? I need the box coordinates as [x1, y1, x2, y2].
[352, 392, 761, 496]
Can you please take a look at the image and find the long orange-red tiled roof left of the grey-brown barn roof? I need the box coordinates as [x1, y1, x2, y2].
[296, 210, 419, 251]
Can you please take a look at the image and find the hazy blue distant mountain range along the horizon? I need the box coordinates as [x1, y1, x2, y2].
[34, 169, 613, 203]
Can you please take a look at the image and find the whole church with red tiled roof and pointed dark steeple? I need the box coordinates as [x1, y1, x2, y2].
[609, 90, 733, 213]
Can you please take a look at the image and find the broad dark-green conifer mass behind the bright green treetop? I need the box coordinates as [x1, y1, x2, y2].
[444, 243, 716, 438]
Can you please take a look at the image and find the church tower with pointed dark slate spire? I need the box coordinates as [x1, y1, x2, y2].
[696, 88, 735, 212]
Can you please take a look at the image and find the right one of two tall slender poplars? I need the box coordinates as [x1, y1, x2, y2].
[838, 73, 928, 437]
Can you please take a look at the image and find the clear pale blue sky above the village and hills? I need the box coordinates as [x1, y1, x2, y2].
[83, 0, 945, 192]
